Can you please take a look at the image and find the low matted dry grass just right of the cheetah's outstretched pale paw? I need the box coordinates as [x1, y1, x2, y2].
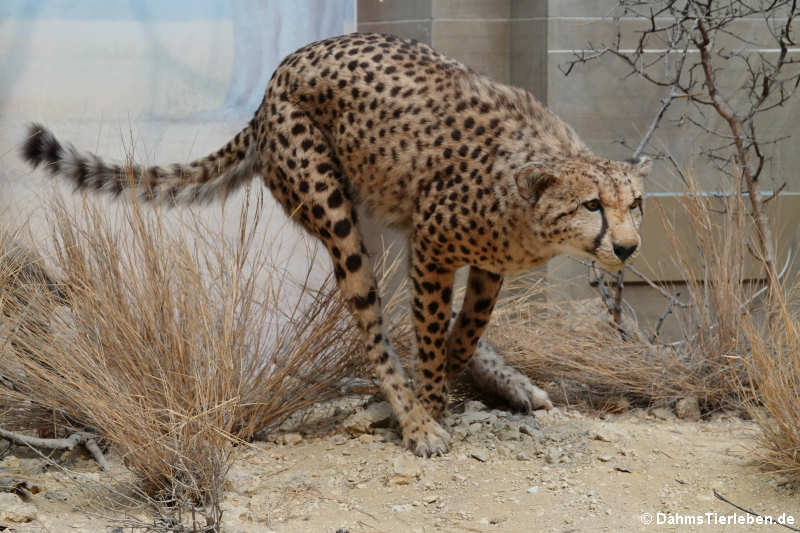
[489, 287, 707, 411]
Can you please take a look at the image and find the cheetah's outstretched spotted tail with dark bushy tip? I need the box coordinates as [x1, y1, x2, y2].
[21, 124, 259, 205]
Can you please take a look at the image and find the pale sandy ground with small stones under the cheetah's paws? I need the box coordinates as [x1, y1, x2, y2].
[0, 400, 800, 533]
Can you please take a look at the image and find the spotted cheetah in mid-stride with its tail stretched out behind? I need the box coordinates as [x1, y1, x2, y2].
[21, 33, 651, 456]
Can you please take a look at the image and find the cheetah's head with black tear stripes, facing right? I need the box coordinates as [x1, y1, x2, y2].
[515, 157, 652, 270]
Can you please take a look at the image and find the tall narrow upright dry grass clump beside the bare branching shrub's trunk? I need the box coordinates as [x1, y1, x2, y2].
[662, 178, 761, 407]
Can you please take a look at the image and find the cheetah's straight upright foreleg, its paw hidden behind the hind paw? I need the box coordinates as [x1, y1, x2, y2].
[410, 243, 454, 420]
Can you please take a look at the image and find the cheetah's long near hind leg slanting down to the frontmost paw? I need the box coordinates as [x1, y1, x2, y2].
[265, 112, 450, 456]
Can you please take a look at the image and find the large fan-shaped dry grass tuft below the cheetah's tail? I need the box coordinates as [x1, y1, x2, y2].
[0, 189, 359, 526]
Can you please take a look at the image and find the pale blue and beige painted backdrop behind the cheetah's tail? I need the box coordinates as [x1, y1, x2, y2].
[0, 0, 355, 286]
